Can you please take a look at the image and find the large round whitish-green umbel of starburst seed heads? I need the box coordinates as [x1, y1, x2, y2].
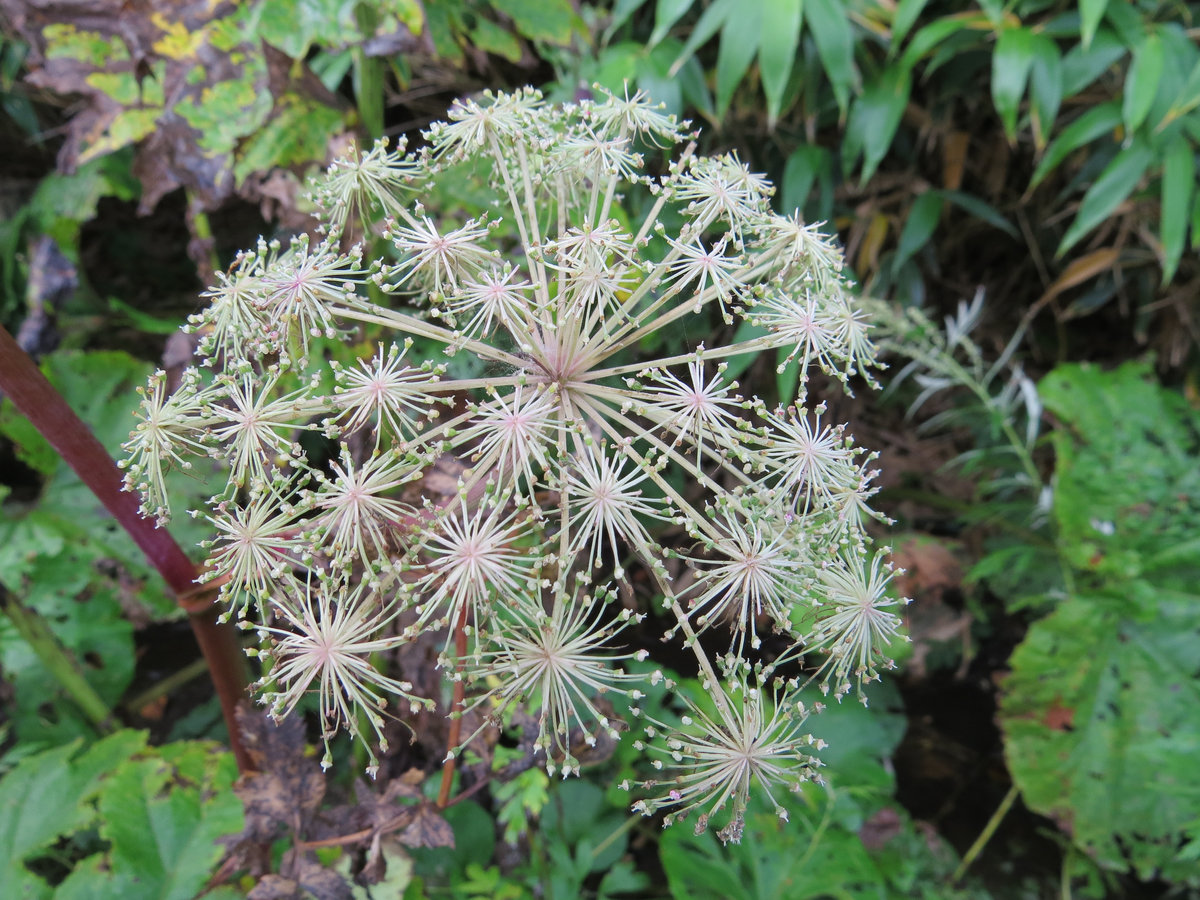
[126, 90, 899, 839]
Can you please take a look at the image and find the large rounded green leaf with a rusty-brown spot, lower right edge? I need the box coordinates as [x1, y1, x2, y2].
[1000, 595, 1200, 884]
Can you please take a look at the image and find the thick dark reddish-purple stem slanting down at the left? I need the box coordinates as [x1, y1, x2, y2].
[0, 326, 254, 772]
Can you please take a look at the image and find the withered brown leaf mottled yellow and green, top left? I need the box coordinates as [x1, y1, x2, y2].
[0, 0, 344, 212]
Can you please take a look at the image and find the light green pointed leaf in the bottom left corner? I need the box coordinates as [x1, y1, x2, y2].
[0, 731, 145, 898]
